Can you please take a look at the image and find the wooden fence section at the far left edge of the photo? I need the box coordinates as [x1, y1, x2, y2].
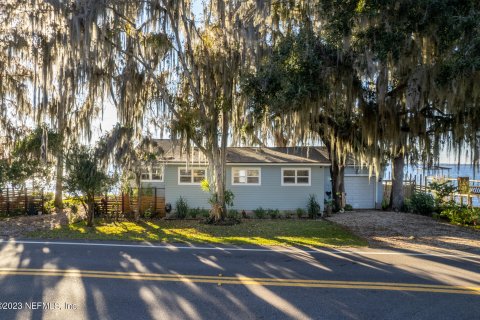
[0, 188, 45, 216]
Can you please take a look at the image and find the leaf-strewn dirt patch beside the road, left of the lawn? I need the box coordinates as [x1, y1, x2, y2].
[0, 209, 83, 239]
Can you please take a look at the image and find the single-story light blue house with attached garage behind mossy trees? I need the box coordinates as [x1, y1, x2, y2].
[141, 140, 382, 211]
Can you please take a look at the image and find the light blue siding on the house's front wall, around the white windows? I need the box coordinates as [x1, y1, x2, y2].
[165, 165, 328, 210]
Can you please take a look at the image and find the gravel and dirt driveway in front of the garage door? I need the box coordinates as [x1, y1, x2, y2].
[327, 211, 480, 251]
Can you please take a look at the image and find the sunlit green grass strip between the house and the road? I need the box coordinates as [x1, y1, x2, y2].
[28, 220, 367, 247]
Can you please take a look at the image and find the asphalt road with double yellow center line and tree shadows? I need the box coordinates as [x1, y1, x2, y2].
[0, 241, 480, 320]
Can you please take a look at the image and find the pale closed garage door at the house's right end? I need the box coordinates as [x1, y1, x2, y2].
[345, 176, 375, 209]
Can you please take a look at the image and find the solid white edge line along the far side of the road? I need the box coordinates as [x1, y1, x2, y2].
[0, 239, 480, 258]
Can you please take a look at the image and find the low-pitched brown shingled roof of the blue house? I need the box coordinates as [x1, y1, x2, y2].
[157, 139, 330, 165]
